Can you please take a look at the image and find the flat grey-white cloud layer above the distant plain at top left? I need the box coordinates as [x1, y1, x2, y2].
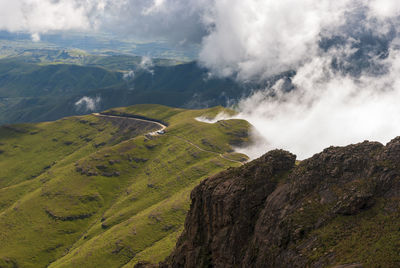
[0, 0, 208, 45]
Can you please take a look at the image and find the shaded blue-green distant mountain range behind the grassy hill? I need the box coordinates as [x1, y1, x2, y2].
[0, 50, 288, 124]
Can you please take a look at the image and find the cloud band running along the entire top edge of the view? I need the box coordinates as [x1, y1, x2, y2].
[0, 0, 400, 50]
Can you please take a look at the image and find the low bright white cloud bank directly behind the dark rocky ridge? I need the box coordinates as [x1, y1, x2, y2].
[239, 48, 400, 159]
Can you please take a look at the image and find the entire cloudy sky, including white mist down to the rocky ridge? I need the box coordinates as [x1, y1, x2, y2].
[0, 0, 400, 158]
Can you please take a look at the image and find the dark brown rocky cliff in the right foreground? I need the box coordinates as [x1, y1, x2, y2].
[155, 138, 400, 267]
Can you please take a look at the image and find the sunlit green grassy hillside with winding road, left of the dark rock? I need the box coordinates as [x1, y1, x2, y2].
[0, 105, 249, 267]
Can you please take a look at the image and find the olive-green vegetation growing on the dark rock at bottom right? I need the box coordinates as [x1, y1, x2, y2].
[288, 176, 400, 267]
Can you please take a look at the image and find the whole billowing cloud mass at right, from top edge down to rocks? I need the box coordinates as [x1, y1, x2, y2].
[190, 0, 400, 159]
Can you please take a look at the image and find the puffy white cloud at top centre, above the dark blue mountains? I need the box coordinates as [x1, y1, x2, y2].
[200, 0, 349, 80]
